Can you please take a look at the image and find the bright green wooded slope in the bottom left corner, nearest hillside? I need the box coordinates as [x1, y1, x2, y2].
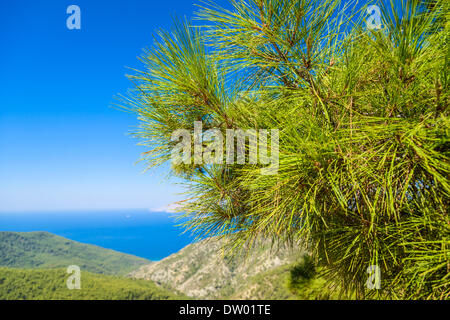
[0, 268, 184, 300]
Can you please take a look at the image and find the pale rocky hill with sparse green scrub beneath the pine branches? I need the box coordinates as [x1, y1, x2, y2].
[130, 238, 312, 299]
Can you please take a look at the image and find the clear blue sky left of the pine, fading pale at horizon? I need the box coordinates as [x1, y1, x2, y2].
[0, 0, 232, 212]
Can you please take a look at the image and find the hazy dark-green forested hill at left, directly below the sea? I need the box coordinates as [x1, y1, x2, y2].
[0, 232, 150, 275]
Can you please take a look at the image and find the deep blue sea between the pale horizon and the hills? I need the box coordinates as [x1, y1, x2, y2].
[0, 210, 193, 261]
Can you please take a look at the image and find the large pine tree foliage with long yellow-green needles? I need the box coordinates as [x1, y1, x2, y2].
[121, 0, 450, 299]
